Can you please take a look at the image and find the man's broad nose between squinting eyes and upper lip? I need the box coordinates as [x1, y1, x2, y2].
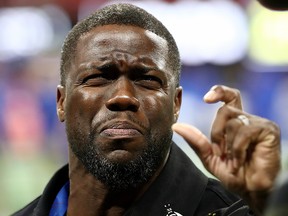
[106, 78, 140, 112]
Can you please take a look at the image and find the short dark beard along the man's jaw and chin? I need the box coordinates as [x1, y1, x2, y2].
[66, 123, 172, 192]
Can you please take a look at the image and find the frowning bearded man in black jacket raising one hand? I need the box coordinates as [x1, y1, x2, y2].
[14, 4, 280, 216]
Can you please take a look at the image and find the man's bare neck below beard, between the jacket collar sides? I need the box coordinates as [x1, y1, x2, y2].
[67, 148, 168, 216]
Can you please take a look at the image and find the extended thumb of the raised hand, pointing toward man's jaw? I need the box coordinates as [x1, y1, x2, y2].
[172, 123, 212, 160]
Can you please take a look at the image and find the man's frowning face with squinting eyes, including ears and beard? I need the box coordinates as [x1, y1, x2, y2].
[57, 25, 181, 187]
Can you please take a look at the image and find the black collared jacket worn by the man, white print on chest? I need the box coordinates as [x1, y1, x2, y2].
[13, 144, 252, 216]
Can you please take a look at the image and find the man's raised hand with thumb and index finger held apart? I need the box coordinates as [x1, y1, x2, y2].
[172, 85, 280, 213]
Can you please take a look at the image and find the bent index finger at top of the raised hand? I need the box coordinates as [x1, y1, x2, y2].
[203, 85, 242, 110]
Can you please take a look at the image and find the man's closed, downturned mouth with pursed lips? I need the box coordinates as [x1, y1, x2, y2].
[100, 122, 142, 138]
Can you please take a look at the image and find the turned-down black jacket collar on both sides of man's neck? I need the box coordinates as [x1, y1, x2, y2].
[33, 143, 208, 216]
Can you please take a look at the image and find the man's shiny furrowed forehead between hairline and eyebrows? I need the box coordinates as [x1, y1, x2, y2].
[77, 24, 168, 67]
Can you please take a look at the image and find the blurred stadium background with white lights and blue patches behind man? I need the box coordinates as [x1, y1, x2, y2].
[0, 0, 288, 216]
